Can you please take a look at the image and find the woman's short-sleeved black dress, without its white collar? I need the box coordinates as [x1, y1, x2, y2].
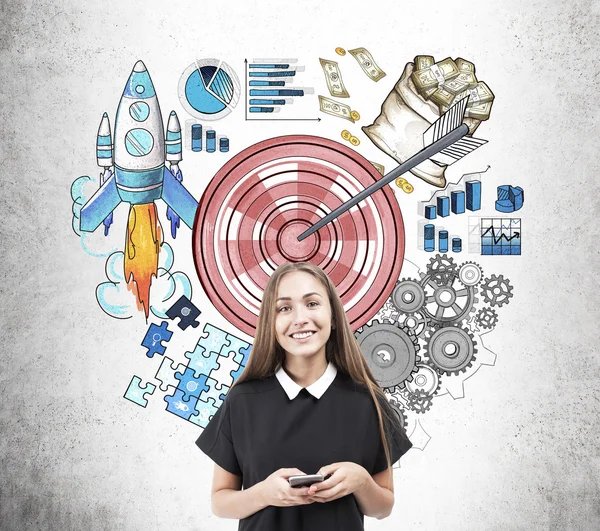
[196, 370, 412, 531]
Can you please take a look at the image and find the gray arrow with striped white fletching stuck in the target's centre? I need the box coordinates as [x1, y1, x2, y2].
[298, 96, 487, 242]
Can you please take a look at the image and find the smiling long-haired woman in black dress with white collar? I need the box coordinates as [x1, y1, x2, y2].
[196, 262, 412, 531]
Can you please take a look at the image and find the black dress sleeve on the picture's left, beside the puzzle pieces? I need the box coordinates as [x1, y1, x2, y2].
[196, 396, 242, 476]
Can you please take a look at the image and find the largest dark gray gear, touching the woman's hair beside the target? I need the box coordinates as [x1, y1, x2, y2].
[354, 319, 421, 390]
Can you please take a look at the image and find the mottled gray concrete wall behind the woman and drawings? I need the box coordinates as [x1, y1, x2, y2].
[0, 0, 600, 531]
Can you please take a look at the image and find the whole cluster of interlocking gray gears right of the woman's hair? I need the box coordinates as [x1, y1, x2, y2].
[364, 254, 513, 426]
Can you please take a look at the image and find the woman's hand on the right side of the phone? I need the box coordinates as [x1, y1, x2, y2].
[308, 461, 369, 503]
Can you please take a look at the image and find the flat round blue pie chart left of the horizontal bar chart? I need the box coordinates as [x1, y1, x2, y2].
[178, 59, 240, 120]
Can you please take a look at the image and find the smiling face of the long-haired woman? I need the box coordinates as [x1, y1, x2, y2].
[275, 271, 332, 364]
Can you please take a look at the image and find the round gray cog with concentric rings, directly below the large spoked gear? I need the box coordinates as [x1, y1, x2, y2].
[425, 325, 477, 375]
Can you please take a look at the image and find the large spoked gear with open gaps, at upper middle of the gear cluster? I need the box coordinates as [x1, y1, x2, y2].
[421, 273, 479, 328]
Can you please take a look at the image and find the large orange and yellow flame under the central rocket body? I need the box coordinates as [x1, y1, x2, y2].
[125, 203, 162, 319]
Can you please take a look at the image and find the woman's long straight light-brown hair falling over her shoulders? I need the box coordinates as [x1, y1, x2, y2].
[232, 262, 404, 488]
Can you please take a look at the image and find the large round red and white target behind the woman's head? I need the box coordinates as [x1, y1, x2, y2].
[192, 135, 404, 336]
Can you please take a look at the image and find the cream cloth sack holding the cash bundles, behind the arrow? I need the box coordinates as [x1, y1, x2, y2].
[362, 63, 479, 188]
